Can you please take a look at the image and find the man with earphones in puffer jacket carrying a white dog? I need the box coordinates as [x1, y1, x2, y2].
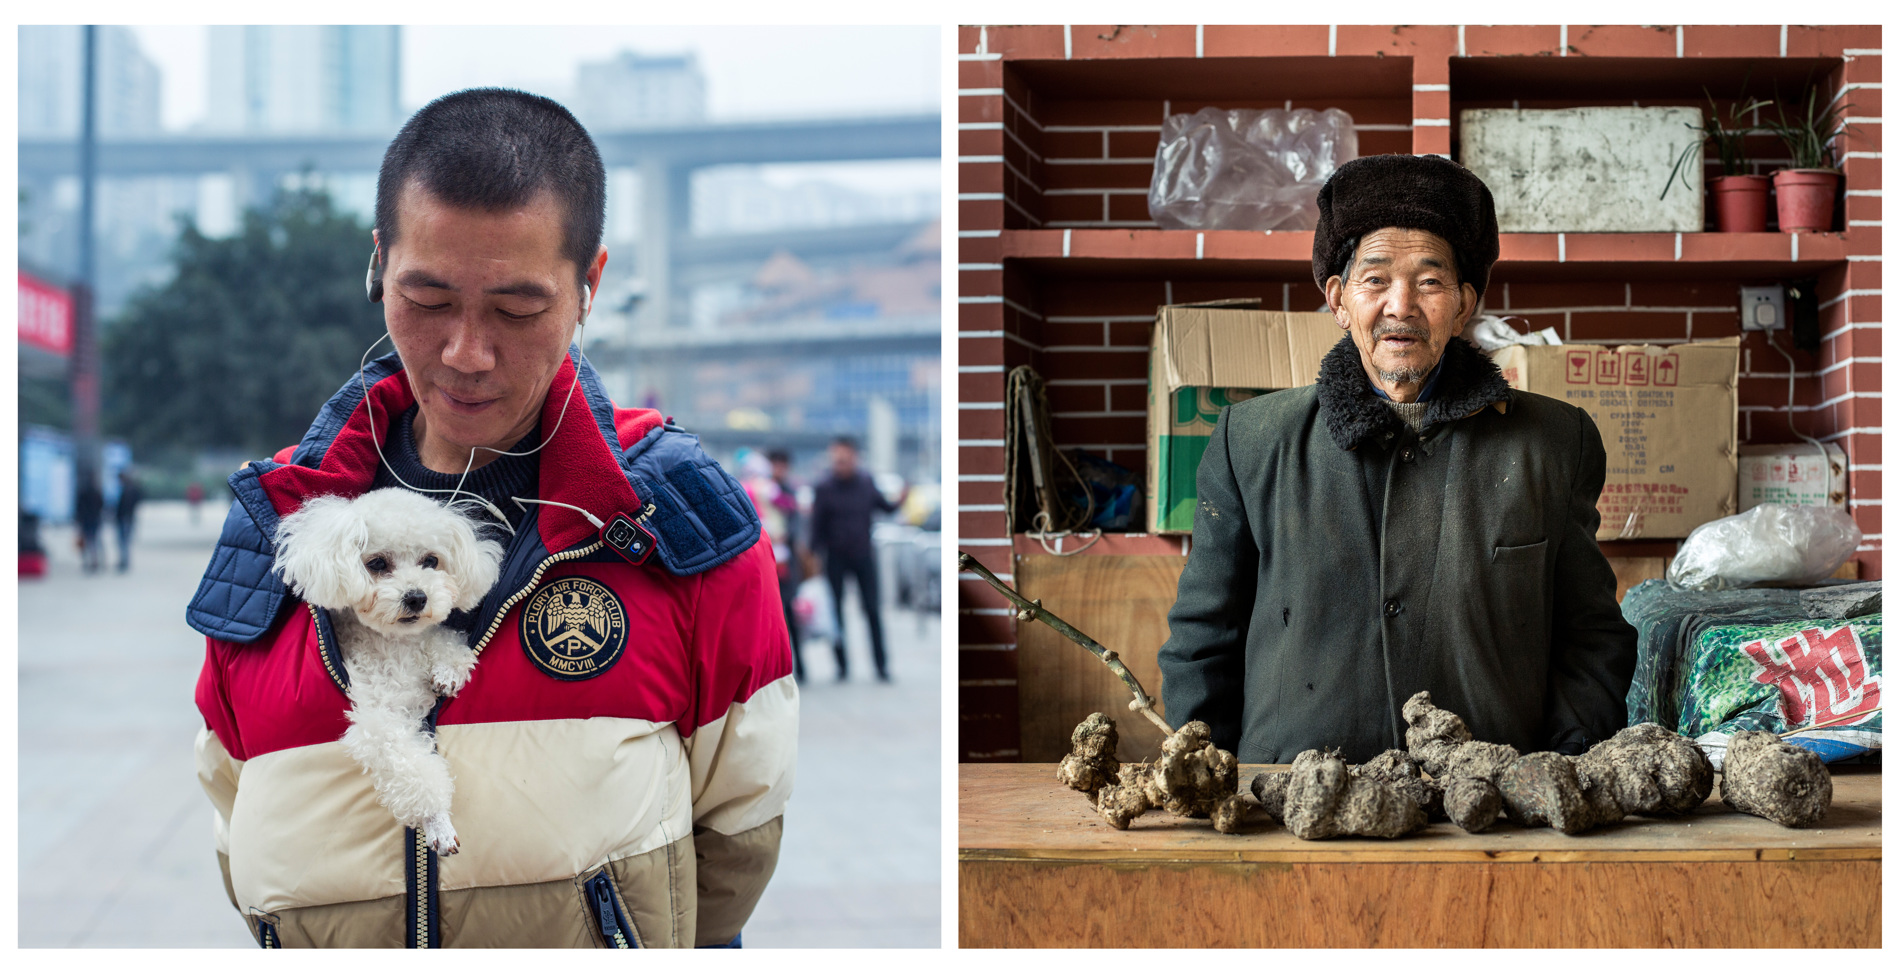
[188, 89, 798, 947]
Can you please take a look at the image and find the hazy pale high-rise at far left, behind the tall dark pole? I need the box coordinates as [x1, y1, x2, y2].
[19, 27, 160, 137]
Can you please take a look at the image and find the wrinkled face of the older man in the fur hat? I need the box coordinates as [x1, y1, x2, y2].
[1326, 228, 1478, 401]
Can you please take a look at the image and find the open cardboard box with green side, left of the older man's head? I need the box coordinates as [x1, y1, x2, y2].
[1148, 300, 1343, 533]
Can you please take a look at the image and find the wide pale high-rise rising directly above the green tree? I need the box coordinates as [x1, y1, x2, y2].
[205, 25, 405, 135]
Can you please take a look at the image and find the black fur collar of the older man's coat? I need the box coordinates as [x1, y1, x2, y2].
[1319, 334, 1511, 450]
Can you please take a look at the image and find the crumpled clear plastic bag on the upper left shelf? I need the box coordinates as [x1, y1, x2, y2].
[1148, 108, 1359, 230]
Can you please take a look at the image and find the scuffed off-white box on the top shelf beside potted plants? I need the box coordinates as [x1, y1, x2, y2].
[1459, 106, 1702, 234]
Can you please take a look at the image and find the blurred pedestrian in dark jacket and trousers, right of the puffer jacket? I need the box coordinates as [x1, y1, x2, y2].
[811, 435, 910, 682]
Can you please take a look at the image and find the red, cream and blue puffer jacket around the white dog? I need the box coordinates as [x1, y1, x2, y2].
[188, 353, 798, 947]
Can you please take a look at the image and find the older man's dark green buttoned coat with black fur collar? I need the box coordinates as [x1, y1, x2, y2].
[1161, 340, 1636, 763]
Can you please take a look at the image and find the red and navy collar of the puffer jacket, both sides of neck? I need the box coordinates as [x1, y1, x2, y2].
[257, 347, 661, 552]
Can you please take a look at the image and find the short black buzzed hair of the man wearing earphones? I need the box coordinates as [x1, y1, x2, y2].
[376, 87, 606, 281]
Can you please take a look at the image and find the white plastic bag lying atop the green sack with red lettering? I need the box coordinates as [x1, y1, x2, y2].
[1668, 503, 1860, 590]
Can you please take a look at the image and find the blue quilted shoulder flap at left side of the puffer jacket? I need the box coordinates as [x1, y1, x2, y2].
[184, 461, 291, 644]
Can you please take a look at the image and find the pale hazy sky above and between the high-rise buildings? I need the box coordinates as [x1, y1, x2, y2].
[133, 25, 942, 188]
